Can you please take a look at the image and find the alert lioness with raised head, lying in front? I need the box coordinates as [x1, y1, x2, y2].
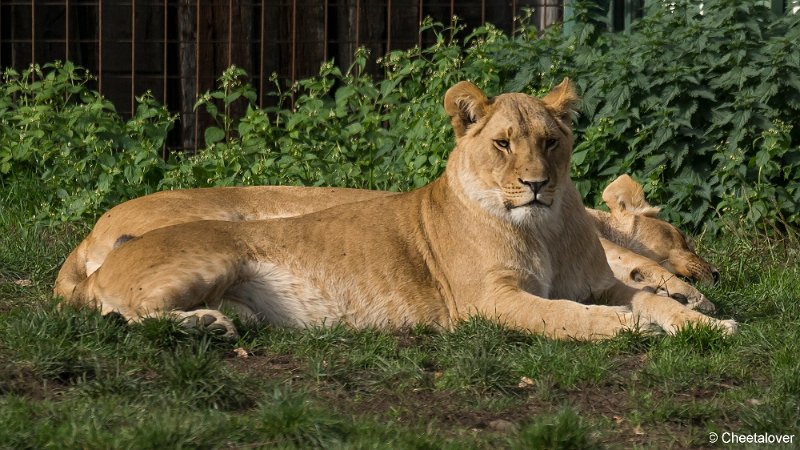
[59, 80, 736, 339]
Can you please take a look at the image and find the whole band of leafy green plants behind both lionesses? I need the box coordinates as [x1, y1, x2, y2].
[0, 0, 800, 231]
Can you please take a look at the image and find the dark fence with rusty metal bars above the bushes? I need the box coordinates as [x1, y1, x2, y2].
[0, 0, 563, 149]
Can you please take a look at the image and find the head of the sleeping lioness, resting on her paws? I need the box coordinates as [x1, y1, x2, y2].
[603, 175, 719, 282]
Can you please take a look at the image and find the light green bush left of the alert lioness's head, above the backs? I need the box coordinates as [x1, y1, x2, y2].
[161, 25, 472, 190]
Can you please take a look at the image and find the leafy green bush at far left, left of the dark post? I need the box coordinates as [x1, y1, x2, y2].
[0, 62, 175, 221]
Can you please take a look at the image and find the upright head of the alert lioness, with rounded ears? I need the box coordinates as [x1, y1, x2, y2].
[444, 79, 578, 223]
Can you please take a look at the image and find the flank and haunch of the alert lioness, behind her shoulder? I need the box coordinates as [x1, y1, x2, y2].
[76, 190, 451, 327]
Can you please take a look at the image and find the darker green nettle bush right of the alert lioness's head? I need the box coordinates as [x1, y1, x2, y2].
[560, 0, 800, 232]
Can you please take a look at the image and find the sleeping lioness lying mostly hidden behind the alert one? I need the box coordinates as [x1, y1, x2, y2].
[54, 181, 719, 312]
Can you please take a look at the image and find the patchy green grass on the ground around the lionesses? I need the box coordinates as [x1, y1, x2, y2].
[0, 201, 800, 449]
